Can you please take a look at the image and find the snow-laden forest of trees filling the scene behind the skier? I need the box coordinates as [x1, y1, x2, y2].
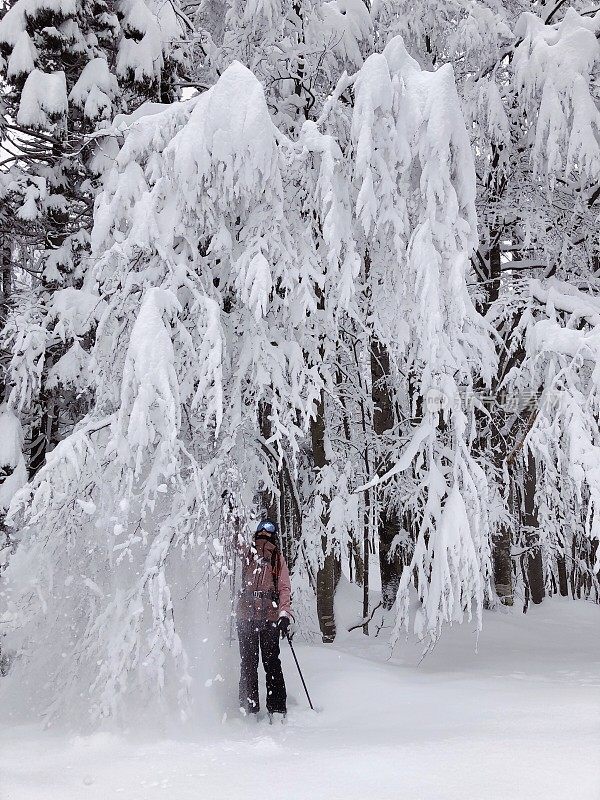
[0, 0, 600, 719]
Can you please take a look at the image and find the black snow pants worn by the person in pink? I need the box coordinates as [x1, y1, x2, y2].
[237, 620, 287, 714]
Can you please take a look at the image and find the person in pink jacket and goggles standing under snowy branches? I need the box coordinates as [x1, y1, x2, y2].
[236, 519, 291, 719]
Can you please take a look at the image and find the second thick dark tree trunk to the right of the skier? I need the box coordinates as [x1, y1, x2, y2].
[370, 338, 402, 609]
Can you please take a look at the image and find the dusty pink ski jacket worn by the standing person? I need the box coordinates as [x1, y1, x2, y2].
[237, 539, 292, 622]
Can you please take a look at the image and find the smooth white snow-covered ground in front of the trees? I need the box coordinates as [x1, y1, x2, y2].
[0, 599, 600, 800]
